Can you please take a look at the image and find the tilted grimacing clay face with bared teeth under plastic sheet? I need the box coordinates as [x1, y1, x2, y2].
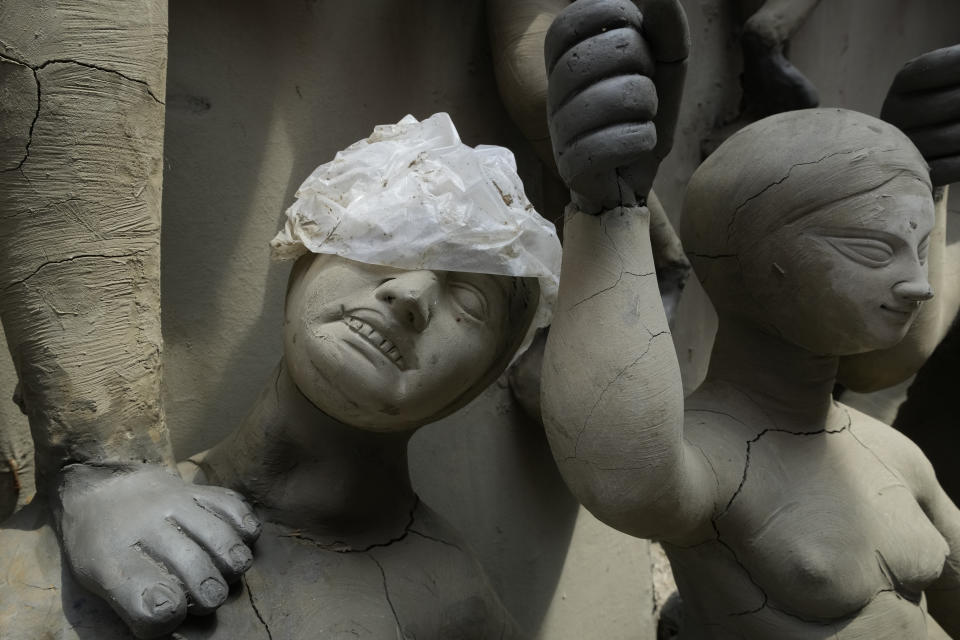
[284, 255, 512, 431]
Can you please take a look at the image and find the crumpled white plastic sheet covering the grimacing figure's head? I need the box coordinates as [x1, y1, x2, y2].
[270, 113, 561, 349]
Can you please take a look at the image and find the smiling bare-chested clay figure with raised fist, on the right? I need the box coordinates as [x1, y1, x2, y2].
[543, 2, 960, 640]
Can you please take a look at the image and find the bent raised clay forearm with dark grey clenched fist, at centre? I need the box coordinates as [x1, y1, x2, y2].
[542, 0, 716, 541]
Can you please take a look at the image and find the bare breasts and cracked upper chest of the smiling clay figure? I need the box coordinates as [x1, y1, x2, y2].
[716, 422, 948, 620]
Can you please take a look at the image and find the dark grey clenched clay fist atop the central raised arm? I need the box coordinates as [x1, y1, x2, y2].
[544, 0, 690, 213]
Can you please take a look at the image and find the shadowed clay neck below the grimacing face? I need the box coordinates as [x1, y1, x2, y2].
[202, 360, 417, 546]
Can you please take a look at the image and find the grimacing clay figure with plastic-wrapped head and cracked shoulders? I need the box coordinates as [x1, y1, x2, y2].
[0, 114, 560, 640]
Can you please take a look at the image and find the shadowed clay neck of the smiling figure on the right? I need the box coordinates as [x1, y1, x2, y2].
[707, 318, 839, 431]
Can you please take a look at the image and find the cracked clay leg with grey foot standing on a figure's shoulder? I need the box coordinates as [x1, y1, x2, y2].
[0, 0, 259, 637]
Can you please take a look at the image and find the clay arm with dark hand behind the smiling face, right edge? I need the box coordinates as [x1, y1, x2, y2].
[838, 45, 960, 391]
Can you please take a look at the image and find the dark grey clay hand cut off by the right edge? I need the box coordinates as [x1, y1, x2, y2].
[880, 45, 960, 186]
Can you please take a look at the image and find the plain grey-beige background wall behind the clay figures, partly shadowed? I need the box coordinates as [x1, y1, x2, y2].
[0, 0, 960, 639]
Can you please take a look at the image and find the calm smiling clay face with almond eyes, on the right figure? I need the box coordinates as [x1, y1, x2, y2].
[741, 174, 934, 356]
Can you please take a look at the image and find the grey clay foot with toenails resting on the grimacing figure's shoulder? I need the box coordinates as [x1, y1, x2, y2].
[55, 465, 260, 638]
